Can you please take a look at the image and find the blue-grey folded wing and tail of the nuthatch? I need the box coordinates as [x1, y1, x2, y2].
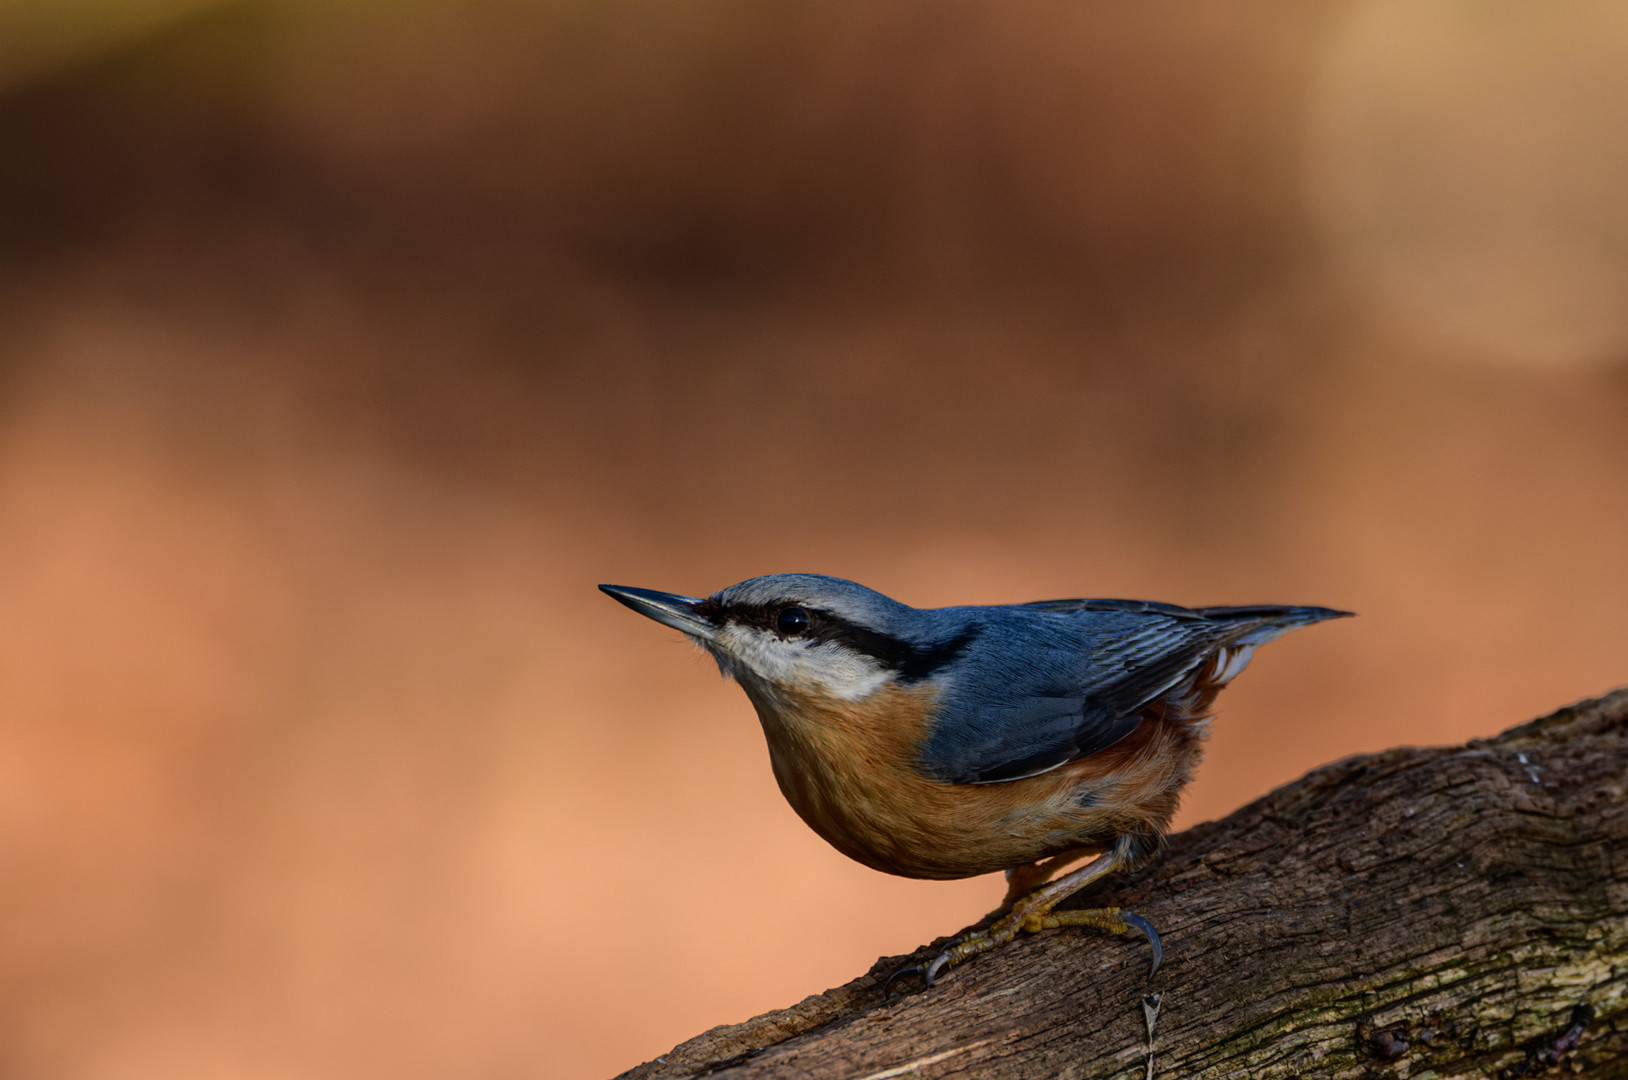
[920, 599, 1345, 784]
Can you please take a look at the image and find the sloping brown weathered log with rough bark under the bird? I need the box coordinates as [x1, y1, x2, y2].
[625, 689, 1628, 1080]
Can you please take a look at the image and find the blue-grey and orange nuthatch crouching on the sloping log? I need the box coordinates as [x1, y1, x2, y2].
[599, 573, 1353, 992]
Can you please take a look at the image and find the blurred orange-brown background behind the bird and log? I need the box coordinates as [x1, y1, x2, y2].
[0, 0, 1628, 1080]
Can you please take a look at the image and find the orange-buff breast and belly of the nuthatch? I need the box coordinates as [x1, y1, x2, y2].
[747, 684, 1203, 878]
